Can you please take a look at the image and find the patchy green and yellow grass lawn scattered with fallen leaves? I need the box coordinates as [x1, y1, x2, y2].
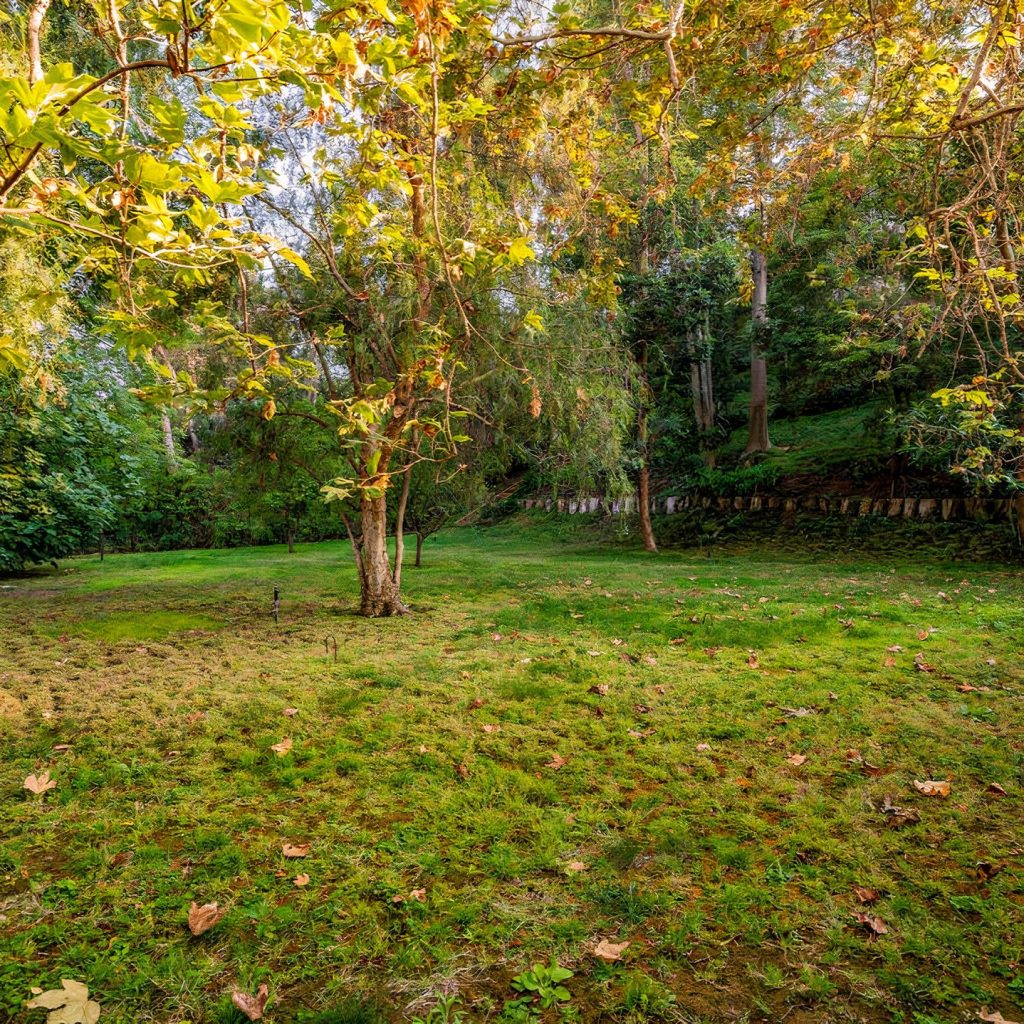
[0, 527, 1024, 1024]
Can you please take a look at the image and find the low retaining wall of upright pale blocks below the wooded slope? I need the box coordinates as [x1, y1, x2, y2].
[519, 495, 1024, 522]
